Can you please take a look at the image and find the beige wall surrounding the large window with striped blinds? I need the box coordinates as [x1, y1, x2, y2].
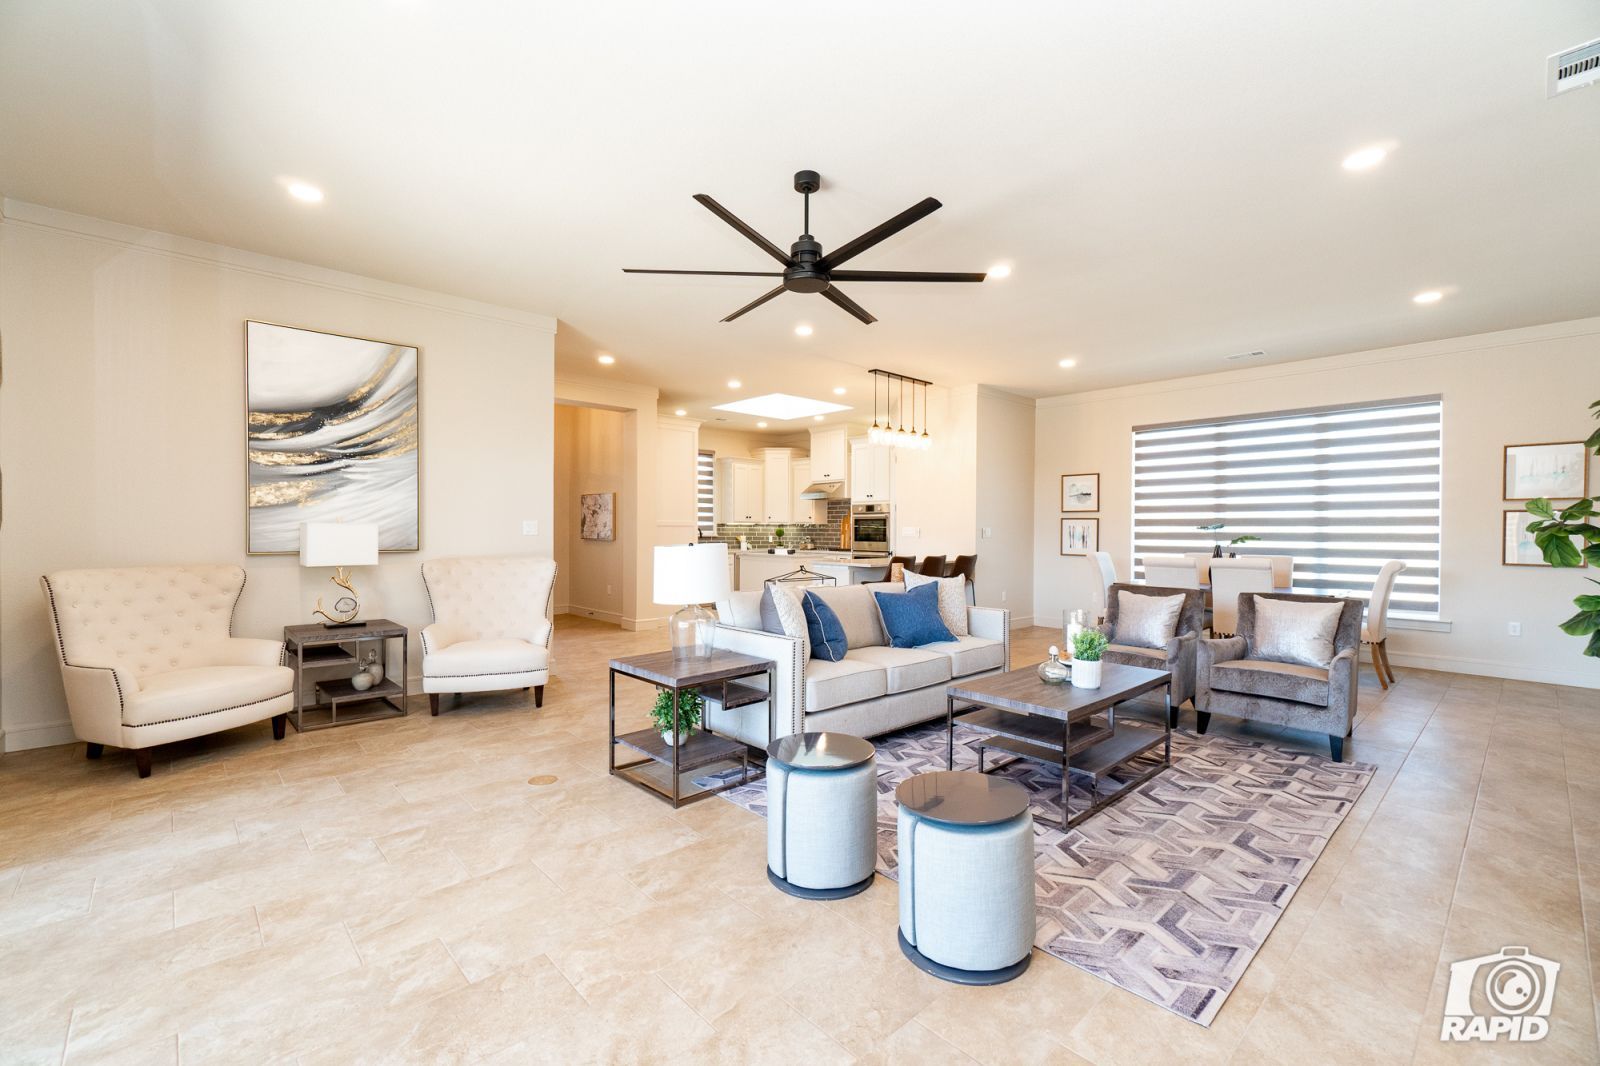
[1034, 319, 1600, 688]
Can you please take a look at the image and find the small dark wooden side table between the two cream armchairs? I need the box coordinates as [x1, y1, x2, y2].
[283, 618, 411, 733]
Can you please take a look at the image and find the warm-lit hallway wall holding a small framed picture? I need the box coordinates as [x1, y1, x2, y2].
[555, 403, 629, 623]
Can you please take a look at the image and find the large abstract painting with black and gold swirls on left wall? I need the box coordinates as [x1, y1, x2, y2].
[245, 322, 422, 555]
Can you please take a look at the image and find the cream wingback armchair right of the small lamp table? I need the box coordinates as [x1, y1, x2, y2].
[422, 555, 555, 714]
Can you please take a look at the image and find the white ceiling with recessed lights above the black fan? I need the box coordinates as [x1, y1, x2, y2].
[0, 0, 1600, 431]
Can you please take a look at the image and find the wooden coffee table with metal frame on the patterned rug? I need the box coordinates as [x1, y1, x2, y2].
[944, 663, 1173, 829]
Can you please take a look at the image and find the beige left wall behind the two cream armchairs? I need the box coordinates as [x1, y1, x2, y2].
[0, 203, 555, 749]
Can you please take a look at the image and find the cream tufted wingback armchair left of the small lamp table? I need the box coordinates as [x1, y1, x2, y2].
[40, 565, 294, 778]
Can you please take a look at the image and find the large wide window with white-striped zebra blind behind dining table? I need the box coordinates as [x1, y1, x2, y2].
[1133, 397, 1443, 618]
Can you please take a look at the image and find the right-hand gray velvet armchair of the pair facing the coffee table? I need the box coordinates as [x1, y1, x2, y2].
[1195, 592, 1362, 762]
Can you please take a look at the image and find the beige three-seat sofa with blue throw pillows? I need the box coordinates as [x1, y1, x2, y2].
[706, 583, 1011, 747]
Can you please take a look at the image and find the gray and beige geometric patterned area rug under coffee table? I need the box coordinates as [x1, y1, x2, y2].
[723, 713, 1374, 1026]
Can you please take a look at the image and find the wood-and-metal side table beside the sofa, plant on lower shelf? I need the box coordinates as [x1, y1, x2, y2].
[606, 651, 776, 808]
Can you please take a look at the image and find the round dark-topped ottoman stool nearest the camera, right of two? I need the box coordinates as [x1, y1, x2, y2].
[894, 770, 1035, 984]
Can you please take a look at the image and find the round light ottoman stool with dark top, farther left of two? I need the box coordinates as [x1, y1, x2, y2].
[766, 733, 878, 900]
